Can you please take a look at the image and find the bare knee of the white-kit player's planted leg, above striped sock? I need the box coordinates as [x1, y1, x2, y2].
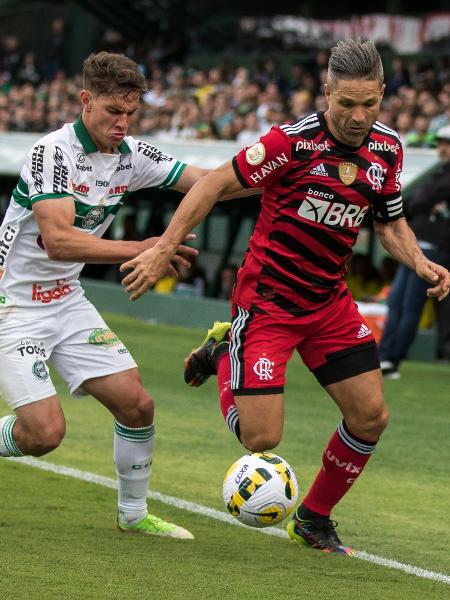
[83, 368, 154, 427]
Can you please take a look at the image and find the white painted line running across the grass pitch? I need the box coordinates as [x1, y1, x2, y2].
[7, 456, 450, 584]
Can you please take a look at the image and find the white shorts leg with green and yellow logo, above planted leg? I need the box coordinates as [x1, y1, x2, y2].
[51, 299, 136, 396]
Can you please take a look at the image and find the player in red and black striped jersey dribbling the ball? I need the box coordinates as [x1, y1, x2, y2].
[123, 40, 450, 554]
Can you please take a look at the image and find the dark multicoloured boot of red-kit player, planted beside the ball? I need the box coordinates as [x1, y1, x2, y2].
[287, 516, 355, 556]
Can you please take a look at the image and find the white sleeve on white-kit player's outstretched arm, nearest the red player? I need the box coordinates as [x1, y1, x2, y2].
[130, 140, 186, 191]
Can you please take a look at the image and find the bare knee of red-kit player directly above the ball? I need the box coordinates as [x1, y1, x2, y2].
[235, 394, 284, 452]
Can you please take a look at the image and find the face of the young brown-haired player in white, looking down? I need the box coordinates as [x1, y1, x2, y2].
[81, 90, 140, 153]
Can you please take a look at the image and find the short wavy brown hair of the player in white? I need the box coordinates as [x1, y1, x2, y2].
[83, 52, 147, 96]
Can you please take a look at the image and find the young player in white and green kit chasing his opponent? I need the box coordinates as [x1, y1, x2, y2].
[0, 52, 211, 539]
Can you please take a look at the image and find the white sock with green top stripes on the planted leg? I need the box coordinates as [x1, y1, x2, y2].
[114, 421, 155, 525]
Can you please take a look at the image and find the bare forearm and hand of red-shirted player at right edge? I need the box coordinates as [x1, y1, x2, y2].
[374, 217, 450, 300]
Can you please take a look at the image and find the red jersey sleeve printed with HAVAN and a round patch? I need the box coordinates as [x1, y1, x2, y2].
[233, 127, 291, 188]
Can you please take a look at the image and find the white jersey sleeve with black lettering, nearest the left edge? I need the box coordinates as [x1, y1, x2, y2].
[26, 140, 74, 204]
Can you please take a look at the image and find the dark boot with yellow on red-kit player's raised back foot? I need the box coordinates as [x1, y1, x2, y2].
[184, 321, 231, 387]
